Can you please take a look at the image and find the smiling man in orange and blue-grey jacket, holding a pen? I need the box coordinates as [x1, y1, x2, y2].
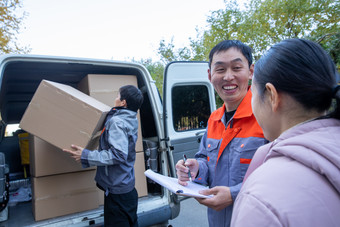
[176, 40, 267, 227]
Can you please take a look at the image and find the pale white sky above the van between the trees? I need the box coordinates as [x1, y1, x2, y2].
[17, 0, 225, 61]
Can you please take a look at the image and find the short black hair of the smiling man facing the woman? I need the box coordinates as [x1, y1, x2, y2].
[209, 40, 253, 68]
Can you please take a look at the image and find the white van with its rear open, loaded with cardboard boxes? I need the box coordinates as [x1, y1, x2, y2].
[0, 55, 216, 227]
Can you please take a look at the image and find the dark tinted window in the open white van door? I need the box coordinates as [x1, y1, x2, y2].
[171, 85, 210, 132]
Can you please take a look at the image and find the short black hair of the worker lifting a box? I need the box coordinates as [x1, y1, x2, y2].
[119, 85, 144, 112]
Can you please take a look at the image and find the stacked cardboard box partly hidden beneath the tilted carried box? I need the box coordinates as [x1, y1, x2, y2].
[28, 135, 96, 177]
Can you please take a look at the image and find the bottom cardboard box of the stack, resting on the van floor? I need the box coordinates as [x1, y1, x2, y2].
[32, 170, 99, 221]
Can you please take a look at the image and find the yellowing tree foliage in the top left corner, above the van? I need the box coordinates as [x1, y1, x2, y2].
[0, 0, 29, 54]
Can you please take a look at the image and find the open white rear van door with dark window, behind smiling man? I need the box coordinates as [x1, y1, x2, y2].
[163, 61, 216, 177]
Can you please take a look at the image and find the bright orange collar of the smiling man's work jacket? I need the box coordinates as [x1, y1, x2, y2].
[211, 86, 253, 121]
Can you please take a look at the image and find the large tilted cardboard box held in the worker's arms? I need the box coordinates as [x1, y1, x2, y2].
[20, 80, 110, 150]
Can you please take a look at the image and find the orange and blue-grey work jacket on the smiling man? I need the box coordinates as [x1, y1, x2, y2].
[195, 89, 268, 227]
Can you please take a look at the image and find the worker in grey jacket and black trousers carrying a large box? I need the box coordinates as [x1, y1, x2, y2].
[64, 85, 143, 226]
